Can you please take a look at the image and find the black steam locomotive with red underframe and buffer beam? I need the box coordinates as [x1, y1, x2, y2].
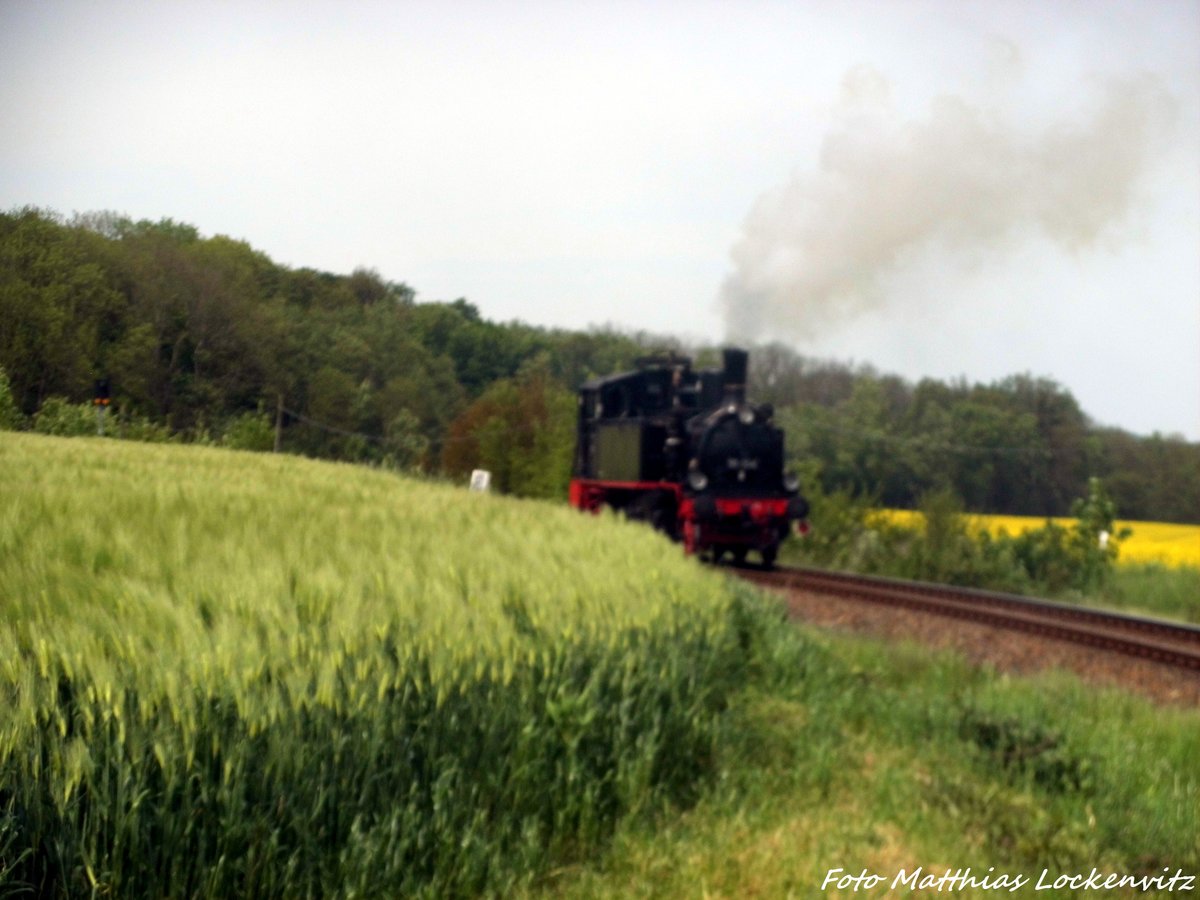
[570, 348, 809, 568]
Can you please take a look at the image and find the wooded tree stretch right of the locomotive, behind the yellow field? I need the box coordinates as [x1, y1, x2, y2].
[750, 344, 1200, 522]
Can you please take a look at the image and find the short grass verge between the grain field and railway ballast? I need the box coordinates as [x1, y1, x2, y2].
[529, 592, 1200, 898]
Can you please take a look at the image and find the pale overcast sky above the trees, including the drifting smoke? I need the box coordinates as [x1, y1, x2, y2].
[0, 0, 1200, 440]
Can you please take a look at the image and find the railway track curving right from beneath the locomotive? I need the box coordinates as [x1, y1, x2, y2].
[734, 568, 1200, 672]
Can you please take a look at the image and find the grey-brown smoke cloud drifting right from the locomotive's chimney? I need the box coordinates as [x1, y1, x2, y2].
[720, 60, 1175, 341]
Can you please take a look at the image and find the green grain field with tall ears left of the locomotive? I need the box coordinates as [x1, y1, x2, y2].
[0, 433, 744, 896]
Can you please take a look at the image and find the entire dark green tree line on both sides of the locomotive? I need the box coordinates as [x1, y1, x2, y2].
[0, 208, 1200, 522]
